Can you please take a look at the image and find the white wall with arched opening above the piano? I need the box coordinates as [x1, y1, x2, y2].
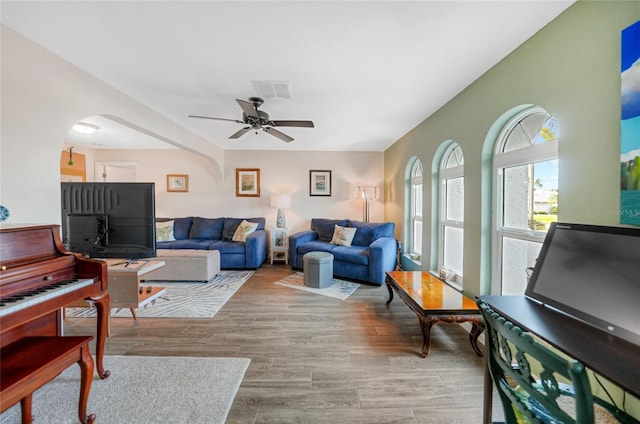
[0, 26, 223, 224]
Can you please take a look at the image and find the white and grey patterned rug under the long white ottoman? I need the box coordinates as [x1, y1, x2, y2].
[66, 271, 253, 318]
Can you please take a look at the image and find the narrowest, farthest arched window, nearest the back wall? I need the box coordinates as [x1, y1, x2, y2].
[405, 159, 422, 262]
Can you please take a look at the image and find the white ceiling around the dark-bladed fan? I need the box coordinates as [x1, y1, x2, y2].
[0, 0, 574, 151]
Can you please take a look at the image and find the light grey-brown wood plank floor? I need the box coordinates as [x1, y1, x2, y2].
[65, 265, 502, 424]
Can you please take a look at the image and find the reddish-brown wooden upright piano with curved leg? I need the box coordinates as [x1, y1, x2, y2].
[0, 225, 110, 379]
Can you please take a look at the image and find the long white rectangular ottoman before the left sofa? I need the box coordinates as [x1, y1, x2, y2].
[144, 249, 220, 281]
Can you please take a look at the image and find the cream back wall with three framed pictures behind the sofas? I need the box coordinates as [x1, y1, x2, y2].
[92, 150, 384, 232]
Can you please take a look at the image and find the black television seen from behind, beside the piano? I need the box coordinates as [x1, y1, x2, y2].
[61, 183, 156, 259]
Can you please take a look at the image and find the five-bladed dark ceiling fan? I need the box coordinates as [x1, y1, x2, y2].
[189, 97, 313, 143]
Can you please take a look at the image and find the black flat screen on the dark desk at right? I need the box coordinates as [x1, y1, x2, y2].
[525, 223, 640, 346]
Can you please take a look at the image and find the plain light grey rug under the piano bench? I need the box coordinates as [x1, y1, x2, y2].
[0, 356, 250, 424]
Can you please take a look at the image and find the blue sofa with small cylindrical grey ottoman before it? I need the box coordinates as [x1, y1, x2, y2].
[289, 218, 398, 285]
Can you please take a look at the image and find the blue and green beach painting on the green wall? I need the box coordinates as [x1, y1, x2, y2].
[620, 21, 640, 225]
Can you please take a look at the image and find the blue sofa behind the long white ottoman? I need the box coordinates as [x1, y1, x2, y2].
[156, 216, 267, 269]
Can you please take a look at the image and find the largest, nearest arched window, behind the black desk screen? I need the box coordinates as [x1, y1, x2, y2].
[491, 107, 558, 295]
